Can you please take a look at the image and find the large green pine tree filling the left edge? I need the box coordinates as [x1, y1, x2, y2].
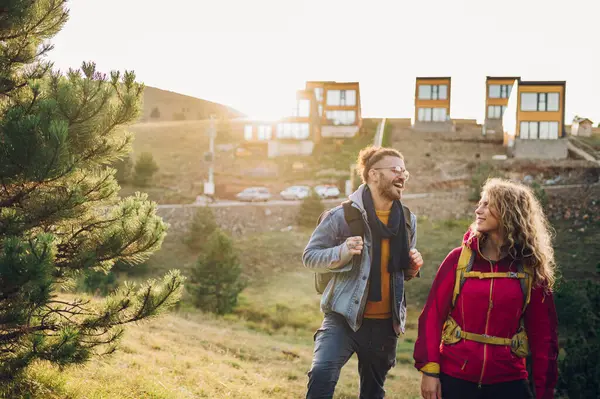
[0, 0, 183, 385]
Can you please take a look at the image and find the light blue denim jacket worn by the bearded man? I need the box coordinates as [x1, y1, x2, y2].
[302, 184, 417, 334]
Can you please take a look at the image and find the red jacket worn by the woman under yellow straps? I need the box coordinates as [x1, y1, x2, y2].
[414, 231, 558, 399]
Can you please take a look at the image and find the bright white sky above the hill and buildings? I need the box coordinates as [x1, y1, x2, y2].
[50, 0, 600, 123]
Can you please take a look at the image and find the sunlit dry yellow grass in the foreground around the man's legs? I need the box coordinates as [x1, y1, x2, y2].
[27, 314, 418, 399]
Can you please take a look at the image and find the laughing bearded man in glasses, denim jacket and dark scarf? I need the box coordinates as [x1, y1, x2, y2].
[302, 147, 423, 399]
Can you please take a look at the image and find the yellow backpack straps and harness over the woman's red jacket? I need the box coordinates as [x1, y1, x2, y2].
[442, 244, 533, 357]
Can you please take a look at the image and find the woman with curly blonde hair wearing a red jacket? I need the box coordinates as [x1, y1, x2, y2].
[414, 179, 558, 399]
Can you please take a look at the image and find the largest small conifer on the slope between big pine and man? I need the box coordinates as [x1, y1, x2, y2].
[188, 229, 245, 314]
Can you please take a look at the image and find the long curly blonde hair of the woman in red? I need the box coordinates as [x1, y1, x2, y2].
[471, 178, 556, 290]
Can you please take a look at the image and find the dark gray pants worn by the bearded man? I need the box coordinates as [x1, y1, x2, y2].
[306, 313, 398, 399]
